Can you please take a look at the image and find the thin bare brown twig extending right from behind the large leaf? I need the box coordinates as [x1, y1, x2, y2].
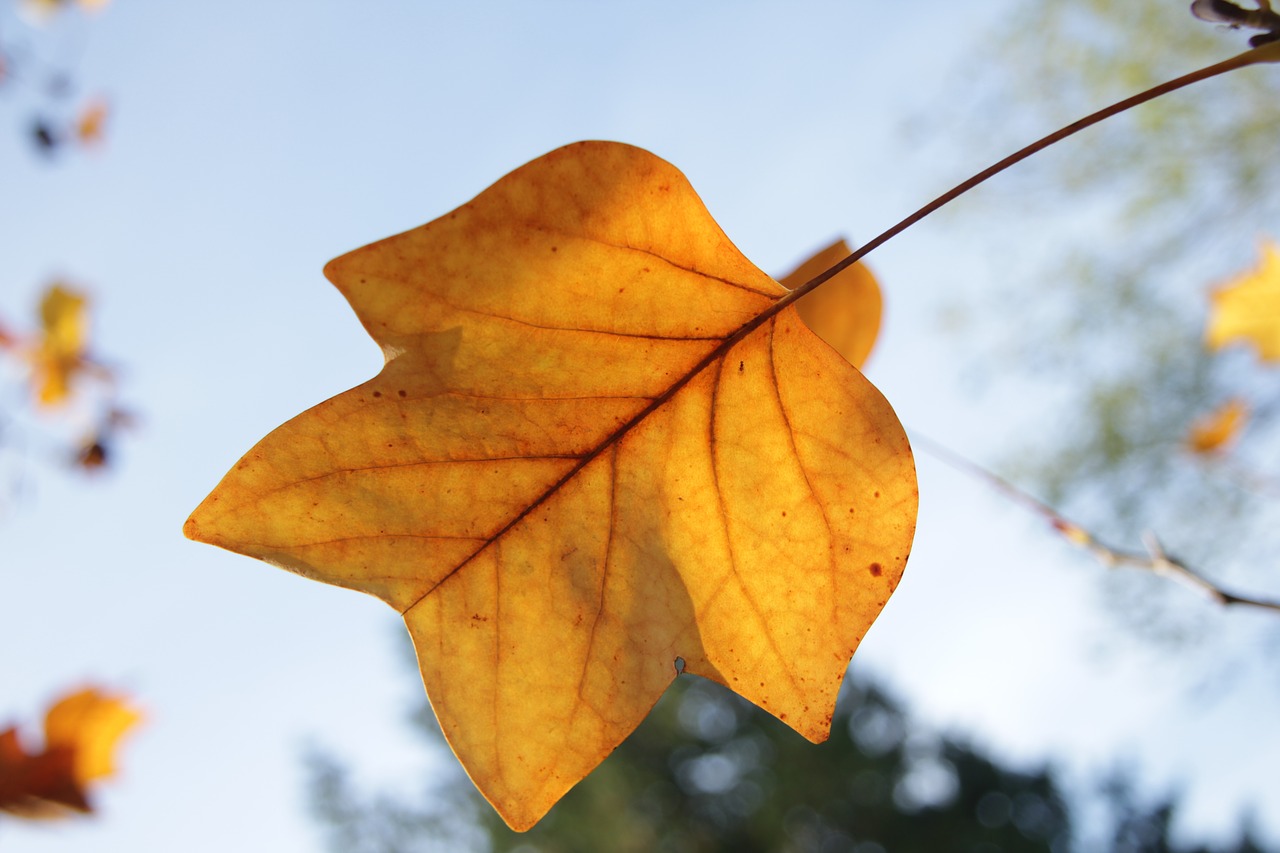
[911, 430, 1280, 612]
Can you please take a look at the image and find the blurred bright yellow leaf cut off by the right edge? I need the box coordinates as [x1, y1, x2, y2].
[1204, 241, 1280, 361]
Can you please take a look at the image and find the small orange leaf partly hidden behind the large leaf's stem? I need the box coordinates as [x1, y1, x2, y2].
[778, 240, 882, 368]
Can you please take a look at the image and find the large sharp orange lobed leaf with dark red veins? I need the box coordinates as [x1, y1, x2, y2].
[186, 142, 916, 829]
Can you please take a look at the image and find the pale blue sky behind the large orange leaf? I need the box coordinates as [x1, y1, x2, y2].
[0, 0, 1280, 853]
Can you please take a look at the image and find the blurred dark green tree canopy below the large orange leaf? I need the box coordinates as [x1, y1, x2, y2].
[304, 676, 1263, 853]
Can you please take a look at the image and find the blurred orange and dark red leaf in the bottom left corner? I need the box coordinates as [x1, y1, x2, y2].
[0, 688, 141, 820]
